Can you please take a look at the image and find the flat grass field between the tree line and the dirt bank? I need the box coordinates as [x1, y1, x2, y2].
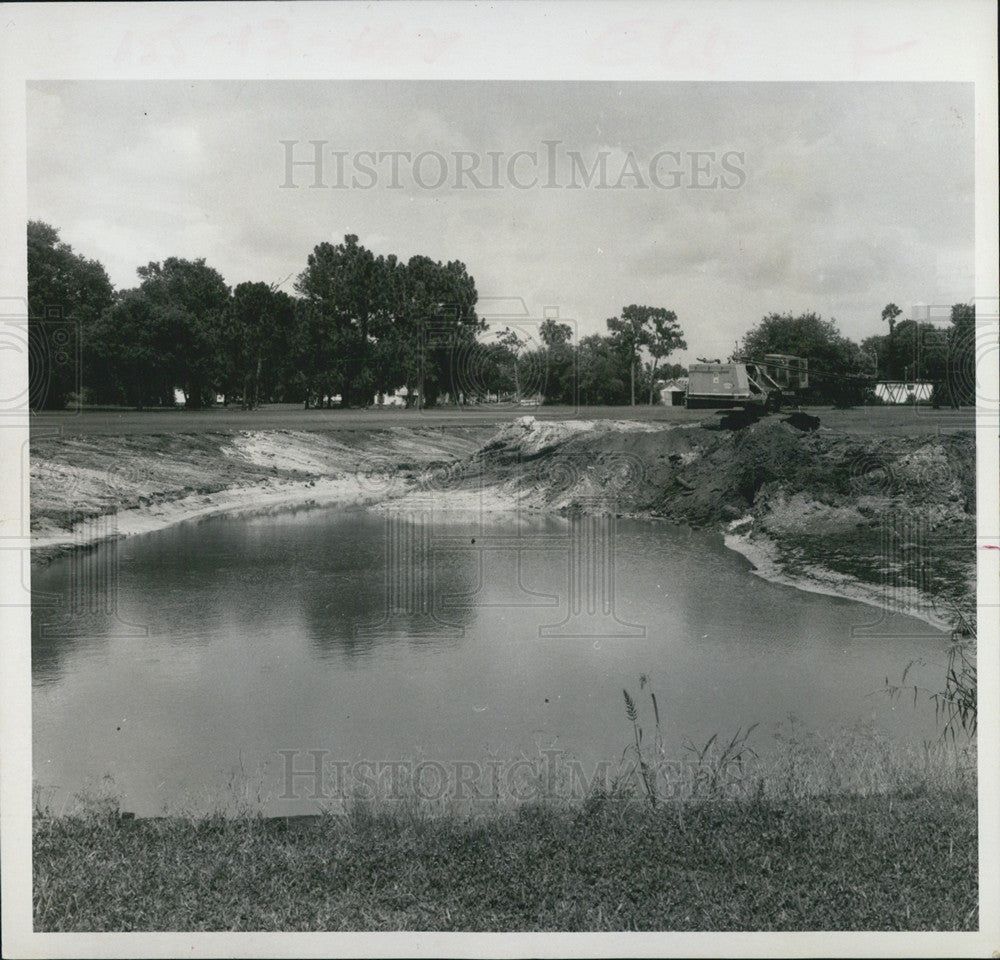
[30, 404, 975, 437]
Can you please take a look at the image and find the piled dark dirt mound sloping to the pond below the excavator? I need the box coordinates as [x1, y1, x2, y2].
[456, 417, 976, 624]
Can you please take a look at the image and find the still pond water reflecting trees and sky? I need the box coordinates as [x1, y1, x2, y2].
[32, 507, 945, 815]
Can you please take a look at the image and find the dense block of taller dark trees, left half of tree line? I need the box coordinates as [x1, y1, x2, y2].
[28, 221, 483, 408]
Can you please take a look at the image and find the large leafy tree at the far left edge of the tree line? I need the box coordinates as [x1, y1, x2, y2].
[27, 220, 114, 409]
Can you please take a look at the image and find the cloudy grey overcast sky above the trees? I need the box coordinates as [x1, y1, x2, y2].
[28, 81, 974, 360]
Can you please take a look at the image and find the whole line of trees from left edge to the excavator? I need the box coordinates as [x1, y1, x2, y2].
[28, 221, 684, 409]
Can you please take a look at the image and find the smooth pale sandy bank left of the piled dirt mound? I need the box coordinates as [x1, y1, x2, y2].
[30, 427, 493, 562]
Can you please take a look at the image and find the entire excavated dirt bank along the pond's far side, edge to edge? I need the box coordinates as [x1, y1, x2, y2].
[31, 417, 976, 626]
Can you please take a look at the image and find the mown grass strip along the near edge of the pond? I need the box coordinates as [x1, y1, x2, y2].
[34, 789, 978, 931]
